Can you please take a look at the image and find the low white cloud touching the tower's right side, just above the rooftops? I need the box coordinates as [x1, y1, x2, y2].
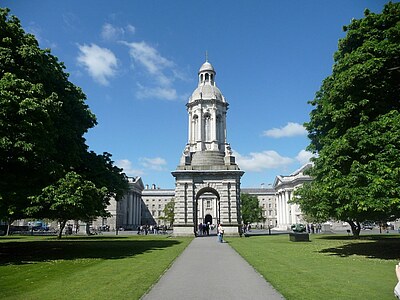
[234, 150, 294, 172]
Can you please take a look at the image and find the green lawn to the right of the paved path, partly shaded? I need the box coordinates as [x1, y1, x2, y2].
[227, 235, 400, 300]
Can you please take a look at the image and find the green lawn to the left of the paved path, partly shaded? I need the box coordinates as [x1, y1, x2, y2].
[0, 236, 191, 299]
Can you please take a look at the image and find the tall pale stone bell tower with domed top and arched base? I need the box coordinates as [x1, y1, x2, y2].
[172, 61, 244, 236]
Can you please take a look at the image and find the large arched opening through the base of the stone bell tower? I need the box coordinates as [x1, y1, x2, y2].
[193, 187, 221, 236]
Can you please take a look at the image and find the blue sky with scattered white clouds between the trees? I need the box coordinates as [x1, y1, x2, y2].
[2, 0, 386, 188]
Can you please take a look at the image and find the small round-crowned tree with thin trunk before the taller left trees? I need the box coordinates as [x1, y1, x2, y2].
[28, 172, 109, 238]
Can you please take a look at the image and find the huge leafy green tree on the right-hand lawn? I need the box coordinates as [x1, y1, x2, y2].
[294, 3, 400, 237]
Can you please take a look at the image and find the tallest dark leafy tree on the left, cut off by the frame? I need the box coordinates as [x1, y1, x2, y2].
[0, 9, 96, 221]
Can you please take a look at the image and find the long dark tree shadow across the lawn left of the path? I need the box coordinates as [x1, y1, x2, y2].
[0, 237, 181, 265]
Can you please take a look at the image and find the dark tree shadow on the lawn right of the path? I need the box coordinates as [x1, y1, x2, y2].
[319, 235, 400, 260]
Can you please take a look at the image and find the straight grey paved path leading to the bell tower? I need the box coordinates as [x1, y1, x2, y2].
[142, 236, 284, 300]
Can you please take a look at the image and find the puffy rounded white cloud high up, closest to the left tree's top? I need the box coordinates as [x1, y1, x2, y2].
[77, 44, 118, 85]
